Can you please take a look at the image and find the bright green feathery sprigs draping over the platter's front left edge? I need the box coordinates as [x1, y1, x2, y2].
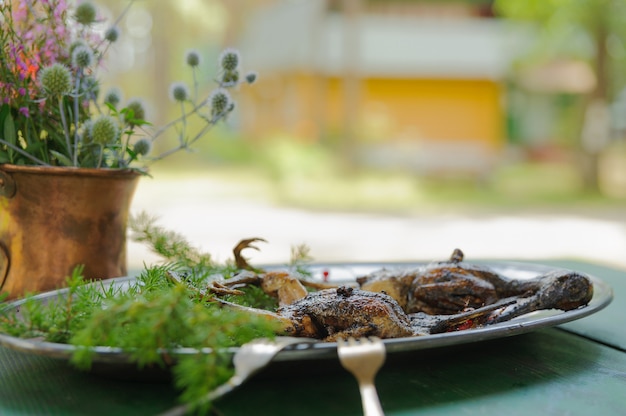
[0, 266, 278, 410]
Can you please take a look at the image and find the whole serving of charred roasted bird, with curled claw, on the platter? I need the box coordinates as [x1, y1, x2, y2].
[169, 239, 593, 341]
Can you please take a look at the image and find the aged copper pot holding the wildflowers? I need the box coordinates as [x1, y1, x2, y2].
[0, 164, 140, 298]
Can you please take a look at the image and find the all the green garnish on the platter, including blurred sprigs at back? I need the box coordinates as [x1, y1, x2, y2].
[0, 214, 309, 412]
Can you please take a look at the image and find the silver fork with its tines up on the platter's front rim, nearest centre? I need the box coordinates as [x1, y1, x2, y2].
[337, 337, 386, 416]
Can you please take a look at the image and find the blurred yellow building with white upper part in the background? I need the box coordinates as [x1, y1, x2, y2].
[240, 0, 517, 176]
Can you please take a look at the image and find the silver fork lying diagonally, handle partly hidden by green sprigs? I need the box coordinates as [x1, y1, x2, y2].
[160, 337, 312, 416]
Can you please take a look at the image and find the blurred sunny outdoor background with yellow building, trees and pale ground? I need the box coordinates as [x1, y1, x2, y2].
[99, 0, 626, 268]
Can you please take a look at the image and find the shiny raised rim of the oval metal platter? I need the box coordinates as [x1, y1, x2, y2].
[0, 260, 613, 365]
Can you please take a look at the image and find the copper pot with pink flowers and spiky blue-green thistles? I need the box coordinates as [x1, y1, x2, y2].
[0, 0, 256, 298]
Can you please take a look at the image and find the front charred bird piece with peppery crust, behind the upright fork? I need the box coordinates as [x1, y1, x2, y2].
[277, 286, 414, 341]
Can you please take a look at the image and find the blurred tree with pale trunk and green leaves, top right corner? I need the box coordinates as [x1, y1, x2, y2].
[494, 0, 626, 191]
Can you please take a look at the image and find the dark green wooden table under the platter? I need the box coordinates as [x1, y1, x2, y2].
[0, 261, 626, 416]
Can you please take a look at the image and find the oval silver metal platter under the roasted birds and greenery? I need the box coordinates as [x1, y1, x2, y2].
[0, 262, 613, 370]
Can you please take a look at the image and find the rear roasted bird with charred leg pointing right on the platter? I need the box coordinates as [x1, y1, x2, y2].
[357, 249, 593, 315]
